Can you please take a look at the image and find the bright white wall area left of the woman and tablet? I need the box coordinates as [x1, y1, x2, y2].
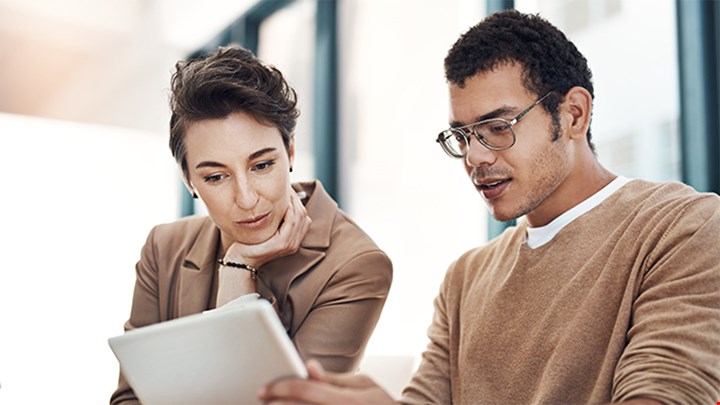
[0, 114, 180, 404]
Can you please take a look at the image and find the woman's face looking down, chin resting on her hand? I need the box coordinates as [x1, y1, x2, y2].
[185, 113, 294, 245]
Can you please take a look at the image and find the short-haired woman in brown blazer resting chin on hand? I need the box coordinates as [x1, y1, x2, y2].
[111, 47, 392, 403]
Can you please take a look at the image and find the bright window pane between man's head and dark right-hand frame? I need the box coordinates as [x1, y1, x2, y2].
[515, 0, 681, 181]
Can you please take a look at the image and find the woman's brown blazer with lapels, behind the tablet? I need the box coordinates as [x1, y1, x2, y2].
[110, 181, 392, 404]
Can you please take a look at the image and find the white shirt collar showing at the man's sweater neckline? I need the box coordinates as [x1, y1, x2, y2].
[526, 176, 631, 249]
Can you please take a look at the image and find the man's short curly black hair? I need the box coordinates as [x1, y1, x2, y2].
[445, 10, 595, 151]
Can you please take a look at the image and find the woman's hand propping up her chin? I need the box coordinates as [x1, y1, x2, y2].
[224, 189, 312, 268]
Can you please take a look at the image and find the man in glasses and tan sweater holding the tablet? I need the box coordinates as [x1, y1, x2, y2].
[260, 11, 720, 404]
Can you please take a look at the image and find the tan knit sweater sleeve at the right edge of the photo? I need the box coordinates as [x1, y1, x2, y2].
[612, 195, 720, 404]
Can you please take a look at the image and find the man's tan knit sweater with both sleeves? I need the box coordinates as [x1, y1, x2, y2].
[402, 180, 720, 404]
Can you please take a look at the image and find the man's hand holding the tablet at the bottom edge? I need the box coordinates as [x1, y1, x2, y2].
[258, 360, 395, 405]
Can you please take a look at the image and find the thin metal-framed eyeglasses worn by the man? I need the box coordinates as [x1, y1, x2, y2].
[435, 91, 552, 159]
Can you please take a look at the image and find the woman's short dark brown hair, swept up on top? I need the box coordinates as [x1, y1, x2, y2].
[170, 45, 300, 179]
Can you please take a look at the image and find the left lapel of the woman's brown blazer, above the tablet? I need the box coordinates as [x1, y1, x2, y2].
[177, 218, 220, 316]
